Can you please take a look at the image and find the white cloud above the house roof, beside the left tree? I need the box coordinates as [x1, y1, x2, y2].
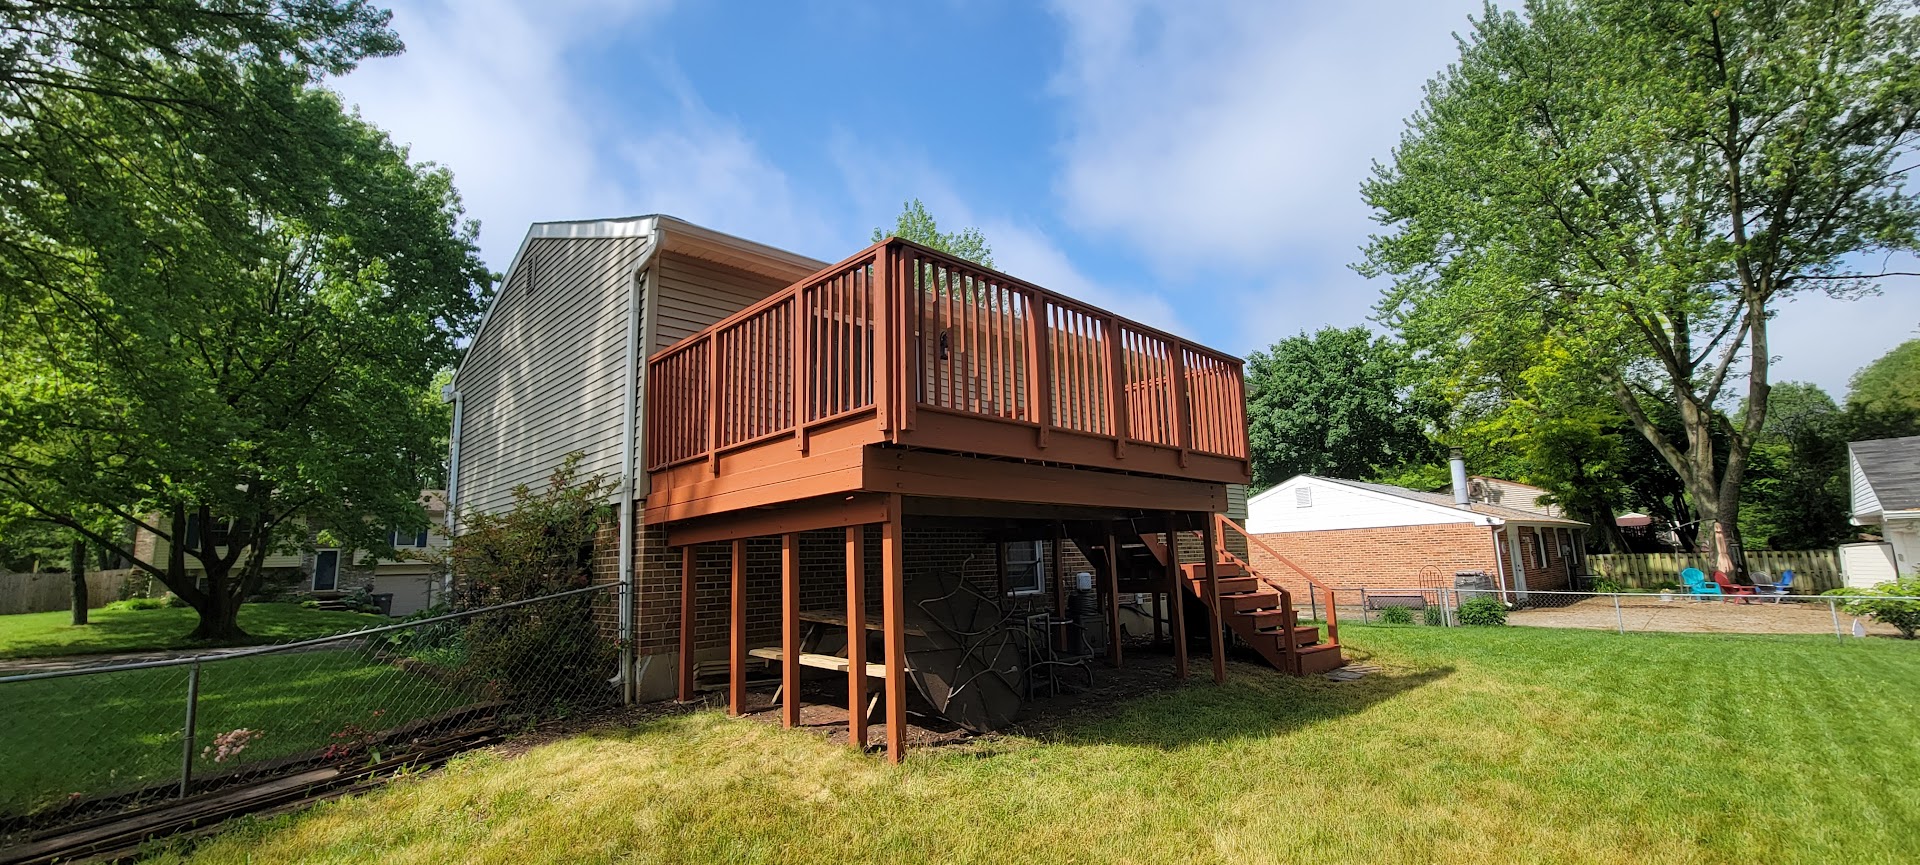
[332, 0, 818, 270]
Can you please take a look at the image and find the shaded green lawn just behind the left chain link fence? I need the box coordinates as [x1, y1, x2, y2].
[0, 648, 474, 815]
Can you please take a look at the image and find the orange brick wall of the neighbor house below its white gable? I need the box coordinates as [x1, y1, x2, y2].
[1254, 524, 1496, 593]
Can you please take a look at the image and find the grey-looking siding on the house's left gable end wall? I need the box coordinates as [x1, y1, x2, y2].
[455, 236, 647, 512]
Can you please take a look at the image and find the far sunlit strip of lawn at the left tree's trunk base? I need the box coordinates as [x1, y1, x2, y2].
[0, 604, 392, 660]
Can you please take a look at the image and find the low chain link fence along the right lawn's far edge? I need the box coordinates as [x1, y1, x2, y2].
[1304, 587, 1920, 641]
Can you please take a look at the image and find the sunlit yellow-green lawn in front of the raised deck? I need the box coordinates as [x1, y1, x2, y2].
[139, 625, 1920, 865]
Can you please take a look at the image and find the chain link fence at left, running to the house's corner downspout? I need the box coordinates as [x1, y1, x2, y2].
[0, 585, 620, 848]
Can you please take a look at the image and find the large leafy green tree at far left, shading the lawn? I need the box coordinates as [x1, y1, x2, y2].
[0, 0, 488, 639]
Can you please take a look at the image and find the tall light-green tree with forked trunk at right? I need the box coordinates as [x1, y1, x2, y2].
[1359, 0, 1920, 568]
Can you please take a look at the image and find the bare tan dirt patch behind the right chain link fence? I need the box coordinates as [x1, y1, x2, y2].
[1507, 595, 1899, 635]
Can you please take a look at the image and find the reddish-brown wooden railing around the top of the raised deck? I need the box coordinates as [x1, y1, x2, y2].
[647, 238, 1246, 472]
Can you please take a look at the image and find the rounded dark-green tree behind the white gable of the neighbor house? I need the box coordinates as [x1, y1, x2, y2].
[1246, 328, 1432, 489]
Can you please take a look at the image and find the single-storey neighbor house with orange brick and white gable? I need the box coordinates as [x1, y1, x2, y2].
[1246, 474, 1586, 602]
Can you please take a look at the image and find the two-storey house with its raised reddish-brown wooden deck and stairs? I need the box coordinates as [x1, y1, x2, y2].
[447, 215, 1340, 758]
